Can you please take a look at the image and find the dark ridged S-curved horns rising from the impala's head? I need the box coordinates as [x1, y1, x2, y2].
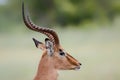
[22, 3, 59, 45]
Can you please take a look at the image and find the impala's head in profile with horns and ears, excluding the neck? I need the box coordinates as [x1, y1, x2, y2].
[22, 4, 81, 70]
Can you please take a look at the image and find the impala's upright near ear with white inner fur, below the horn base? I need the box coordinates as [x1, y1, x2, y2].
[45, 38, 54, 56]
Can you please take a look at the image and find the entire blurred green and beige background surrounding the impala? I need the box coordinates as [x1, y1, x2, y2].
[0, 0, 120, 80]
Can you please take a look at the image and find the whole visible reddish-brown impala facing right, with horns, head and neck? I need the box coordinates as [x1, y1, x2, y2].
[22, 4, 81, 80]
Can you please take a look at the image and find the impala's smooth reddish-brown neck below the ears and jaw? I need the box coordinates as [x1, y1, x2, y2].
[34, 52, 58, 80]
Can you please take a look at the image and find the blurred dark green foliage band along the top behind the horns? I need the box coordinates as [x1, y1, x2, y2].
[0, 0, 120, 28]
